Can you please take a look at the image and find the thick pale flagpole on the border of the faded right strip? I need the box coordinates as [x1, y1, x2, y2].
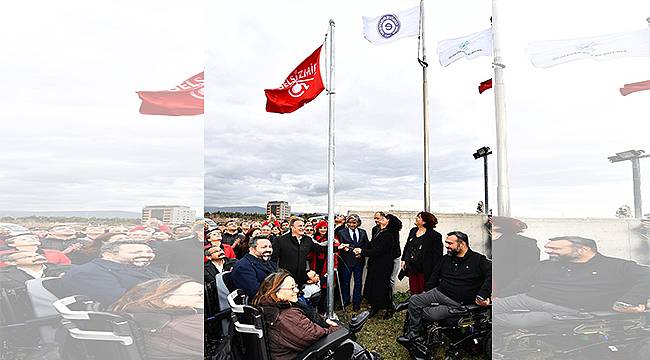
[492, 0, 510, 216]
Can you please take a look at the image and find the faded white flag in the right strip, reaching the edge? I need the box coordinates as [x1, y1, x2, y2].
[528, 28, 650, 68]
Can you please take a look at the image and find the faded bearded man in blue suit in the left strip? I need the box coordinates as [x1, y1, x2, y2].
[60, 240, 169, 306]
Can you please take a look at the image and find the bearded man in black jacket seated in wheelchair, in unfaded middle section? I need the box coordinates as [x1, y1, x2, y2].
[397, 231, 492, 344]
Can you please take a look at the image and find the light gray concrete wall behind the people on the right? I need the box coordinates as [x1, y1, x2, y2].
[349, 211, 650, 291]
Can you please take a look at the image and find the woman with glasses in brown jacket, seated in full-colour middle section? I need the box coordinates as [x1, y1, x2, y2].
[253, 270, 338, 360]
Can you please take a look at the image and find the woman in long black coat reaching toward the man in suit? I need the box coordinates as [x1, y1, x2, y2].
[354, 213, 402, 318]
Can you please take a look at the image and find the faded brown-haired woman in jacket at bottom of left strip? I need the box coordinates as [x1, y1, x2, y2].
[111, 277, 204, 360]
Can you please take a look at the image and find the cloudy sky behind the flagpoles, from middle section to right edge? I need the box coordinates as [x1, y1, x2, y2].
[205, 0, 650, 217]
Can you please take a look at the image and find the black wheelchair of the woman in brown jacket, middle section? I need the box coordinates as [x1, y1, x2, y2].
[228, 290, 380, 360]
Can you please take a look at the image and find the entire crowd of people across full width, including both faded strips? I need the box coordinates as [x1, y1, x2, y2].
[0, 211, 650, 359]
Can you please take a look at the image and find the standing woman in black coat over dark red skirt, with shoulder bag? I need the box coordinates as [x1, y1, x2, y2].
[401, 211, 443, 295]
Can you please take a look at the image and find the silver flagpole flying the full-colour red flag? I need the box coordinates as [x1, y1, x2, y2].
[327, 19, 336, 319]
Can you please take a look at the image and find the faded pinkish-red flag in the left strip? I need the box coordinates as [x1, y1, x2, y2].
[137, 71, 203, 115]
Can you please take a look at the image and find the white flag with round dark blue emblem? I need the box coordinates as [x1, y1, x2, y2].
[363, 6, 420, 45]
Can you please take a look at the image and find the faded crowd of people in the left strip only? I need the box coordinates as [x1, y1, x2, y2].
[0, 219, 204, 359]
